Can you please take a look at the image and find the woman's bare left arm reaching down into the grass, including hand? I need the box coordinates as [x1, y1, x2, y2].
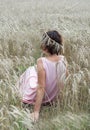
[32, 59, 45, 121]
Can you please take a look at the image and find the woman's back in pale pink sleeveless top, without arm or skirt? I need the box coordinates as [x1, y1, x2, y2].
[42, 56, 66, 102]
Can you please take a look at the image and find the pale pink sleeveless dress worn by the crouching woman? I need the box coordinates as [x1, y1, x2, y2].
[19, 56, 66, 104]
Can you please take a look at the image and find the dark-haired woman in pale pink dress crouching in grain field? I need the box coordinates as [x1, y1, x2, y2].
[19, 31, 67, 120]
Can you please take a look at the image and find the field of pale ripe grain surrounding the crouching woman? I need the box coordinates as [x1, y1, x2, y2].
[0, 0, 90, 130]
